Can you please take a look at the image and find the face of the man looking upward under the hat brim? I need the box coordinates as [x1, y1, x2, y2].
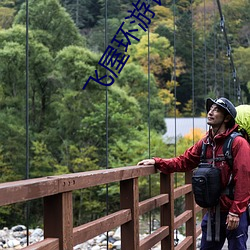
[207, 104, 225, 128]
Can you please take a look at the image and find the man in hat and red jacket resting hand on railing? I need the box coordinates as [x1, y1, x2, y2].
[138, 97, 250, 250]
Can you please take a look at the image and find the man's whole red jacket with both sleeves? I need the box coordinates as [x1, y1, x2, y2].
[154, 125, 250, 215]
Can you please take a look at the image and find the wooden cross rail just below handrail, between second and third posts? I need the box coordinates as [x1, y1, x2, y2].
[139, 194, 169, 215]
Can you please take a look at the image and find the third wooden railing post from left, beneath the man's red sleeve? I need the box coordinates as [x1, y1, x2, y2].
[160, 173, 174, 250]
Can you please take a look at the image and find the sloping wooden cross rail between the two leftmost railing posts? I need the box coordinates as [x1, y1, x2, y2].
[73, 209, 131, 246]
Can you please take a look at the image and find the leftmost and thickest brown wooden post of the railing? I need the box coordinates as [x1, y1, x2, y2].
[44, 192, 73, 250]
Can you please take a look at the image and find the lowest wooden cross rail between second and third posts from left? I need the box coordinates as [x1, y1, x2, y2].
[140, 226, 169, 250]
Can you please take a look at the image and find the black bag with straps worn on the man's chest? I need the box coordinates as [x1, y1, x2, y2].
[192, 132, 242, 208]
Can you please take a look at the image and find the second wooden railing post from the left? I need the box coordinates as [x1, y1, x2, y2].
[120, 178, 139, 250]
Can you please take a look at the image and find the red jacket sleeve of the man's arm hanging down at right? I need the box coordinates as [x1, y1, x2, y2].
[229, 136, 250, 215]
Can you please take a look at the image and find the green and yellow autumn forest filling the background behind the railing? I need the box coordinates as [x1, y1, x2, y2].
[0, 0, 250, 228]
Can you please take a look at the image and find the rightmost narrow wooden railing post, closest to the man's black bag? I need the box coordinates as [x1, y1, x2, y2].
[185, 172, 196, 250]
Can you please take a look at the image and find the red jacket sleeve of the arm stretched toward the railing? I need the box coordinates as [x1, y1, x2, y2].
[153, 140, 202, 174]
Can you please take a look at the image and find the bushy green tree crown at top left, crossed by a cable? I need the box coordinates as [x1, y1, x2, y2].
[14, 0, 84, 52]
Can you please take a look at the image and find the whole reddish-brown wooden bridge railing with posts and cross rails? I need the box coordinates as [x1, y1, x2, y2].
[0, 166, 201, 250]
